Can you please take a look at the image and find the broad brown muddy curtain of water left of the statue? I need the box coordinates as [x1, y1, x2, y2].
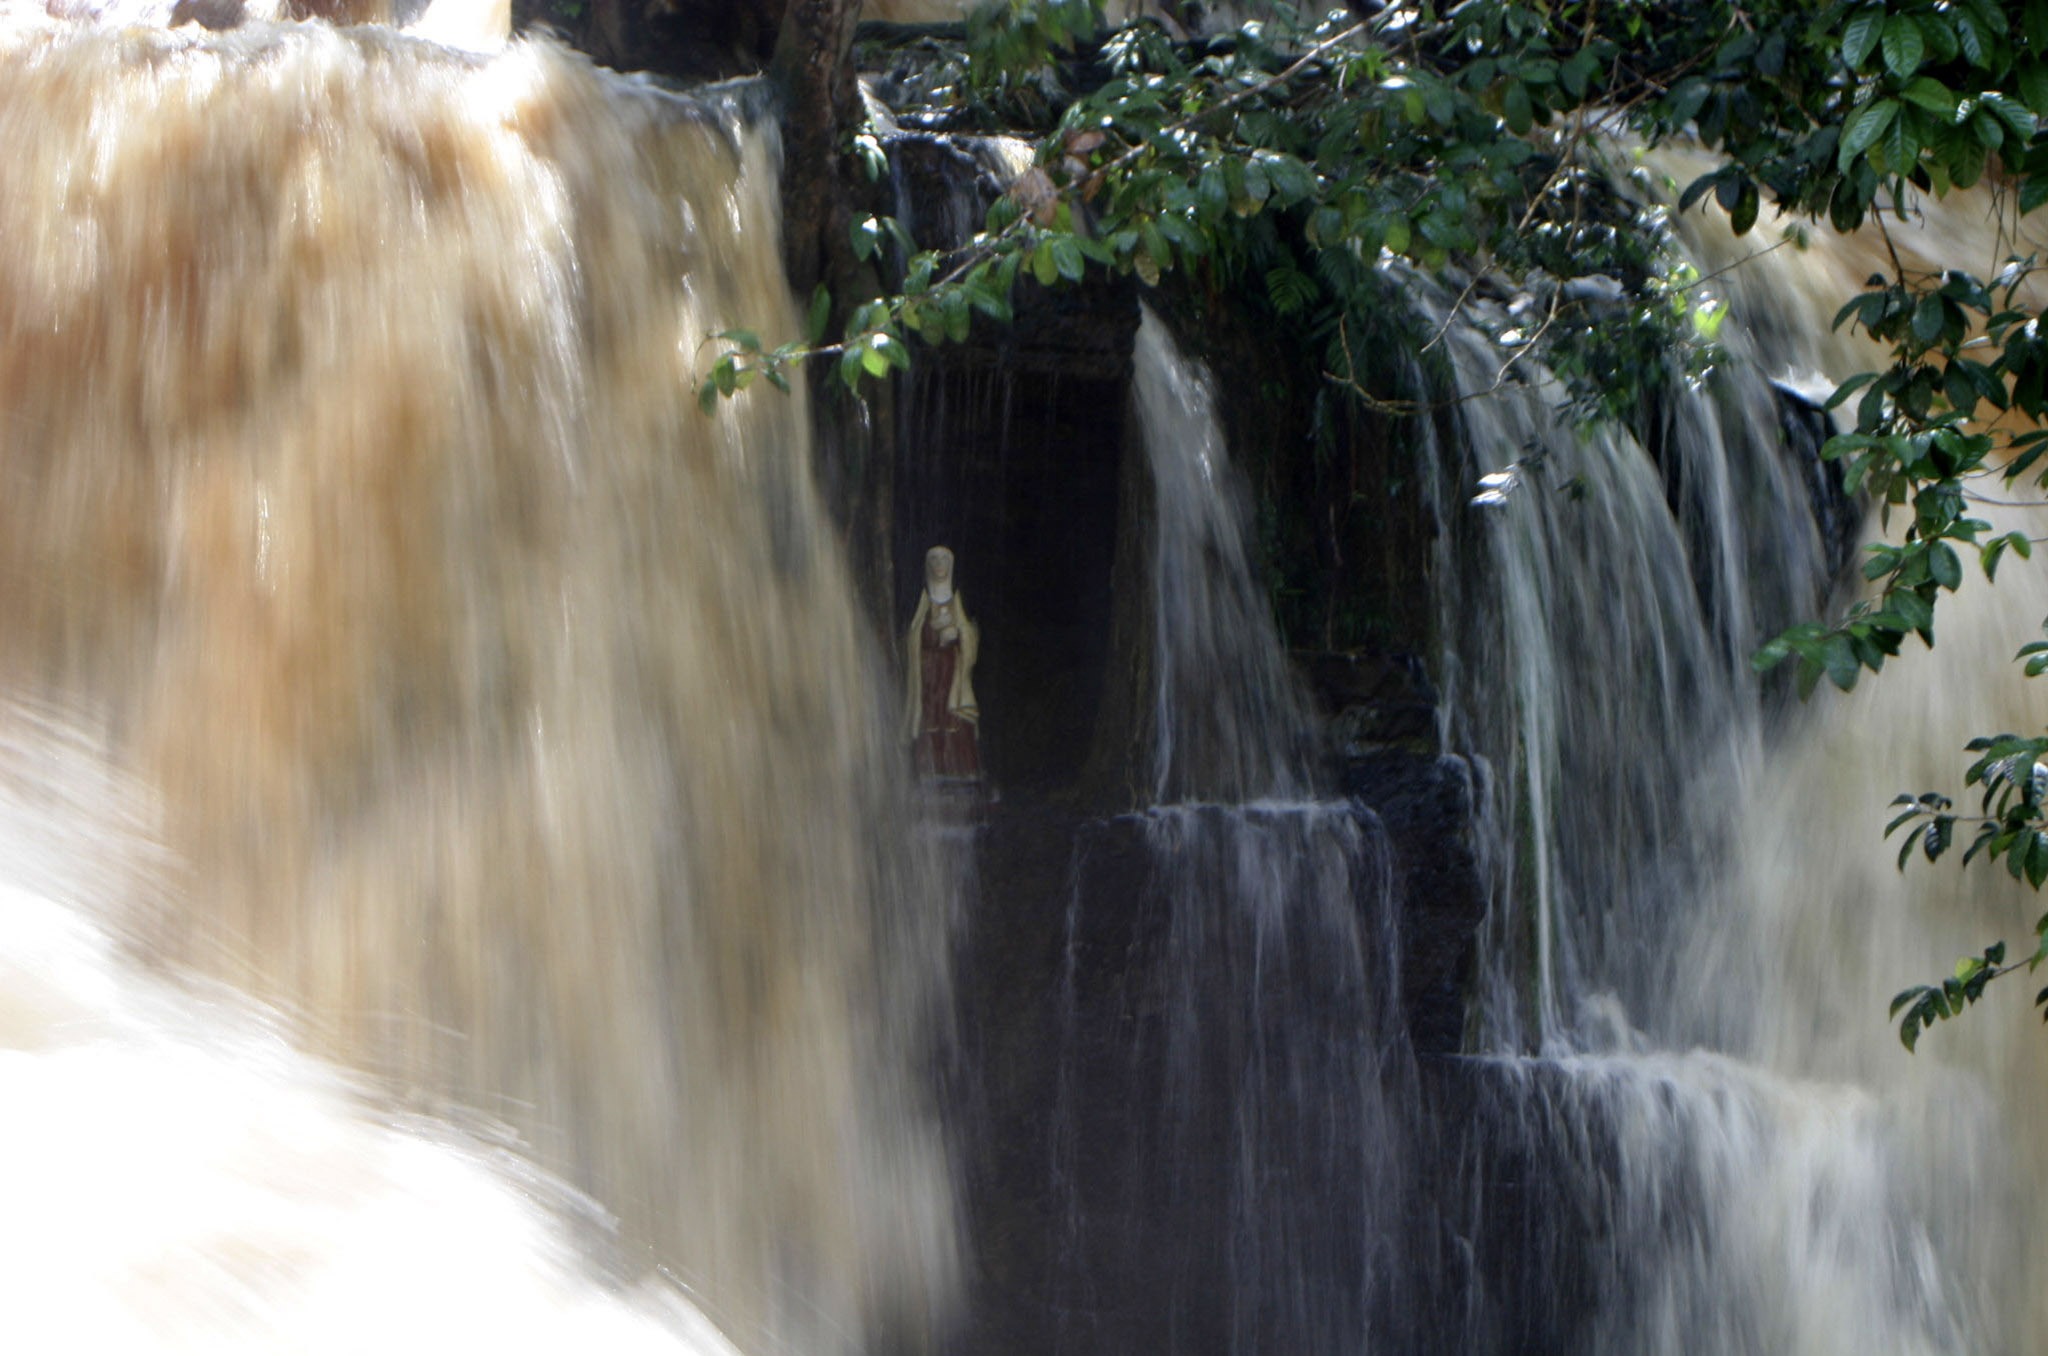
[0, 14, 950, 1352]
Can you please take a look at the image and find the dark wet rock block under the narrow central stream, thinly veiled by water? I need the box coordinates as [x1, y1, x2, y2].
[961, 803, 1411, 1354]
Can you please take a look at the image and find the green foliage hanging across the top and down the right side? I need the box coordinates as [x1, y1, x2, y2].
[802, 0, 2048, 1049]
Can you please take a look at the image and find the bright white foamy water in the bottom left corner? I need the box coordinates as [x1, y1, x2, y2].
[0, 709, 733, 1356]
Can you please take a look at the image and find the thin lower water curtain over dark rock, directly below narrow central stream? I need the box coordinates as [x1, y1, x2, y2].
[1053, 801, 1409, 1356]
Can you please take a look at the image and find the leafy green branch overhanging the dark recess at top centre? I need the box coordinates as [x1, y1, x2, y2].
[700, 0, 1729, 421]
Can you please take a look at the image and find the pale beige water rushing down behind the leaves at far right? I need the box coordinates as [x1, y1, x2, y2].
[1681, 195, 2048, 1352]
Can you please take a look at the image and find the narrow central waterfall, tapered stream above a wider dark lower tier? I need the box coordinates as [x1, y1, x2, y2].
[1051, 311, 1411, 1356]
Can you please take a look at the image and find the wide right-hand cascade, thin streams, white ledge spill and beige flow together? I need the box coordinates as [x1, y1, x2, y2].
[1421, 180, 2048, 1354]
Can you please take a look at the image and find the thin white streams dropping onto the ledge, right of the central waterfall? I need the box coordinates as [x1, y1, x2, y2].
[1409, 268, 1829, 1049]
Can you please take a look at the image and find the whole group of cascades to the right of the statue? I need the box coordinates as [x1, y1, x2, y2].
[1015, 236, 2048, 1356]
